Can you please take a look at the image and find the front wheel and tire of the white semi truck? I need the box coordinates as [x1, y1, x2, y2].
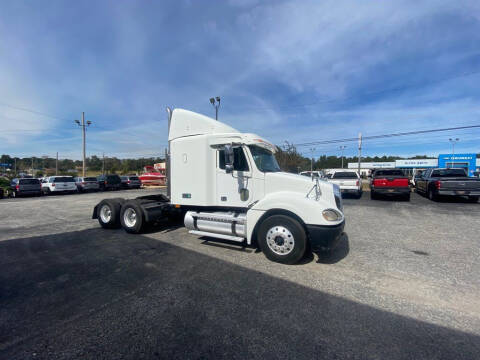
[257, 215, 307, 264]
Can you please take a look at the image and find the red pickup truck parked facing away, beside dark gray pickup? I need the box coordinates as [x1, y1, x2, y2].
[370, 169, 411, 201]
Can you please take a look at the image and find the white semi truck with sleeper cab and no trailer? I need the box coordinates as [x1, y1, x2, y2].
[92, 108, 345, 264]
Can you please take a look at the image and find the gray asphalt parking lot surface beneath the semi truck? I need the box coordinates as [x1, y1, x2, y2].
[0, 190, 480, 359]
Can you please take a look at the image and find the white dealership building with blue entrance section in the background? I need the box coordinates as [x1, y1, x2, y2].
[348, 154, 480, 176]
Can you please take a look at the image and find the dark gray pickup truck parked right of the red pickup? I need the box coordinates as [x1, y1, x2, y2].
[416, 168, 480, 202]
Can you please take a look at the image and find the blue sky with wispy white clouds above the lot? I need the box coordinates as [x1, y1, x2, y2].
[0, 0, 480, 159]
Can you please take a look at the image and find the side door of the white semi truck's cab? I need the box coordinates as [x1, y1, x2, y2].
[216, 146, 253, 207]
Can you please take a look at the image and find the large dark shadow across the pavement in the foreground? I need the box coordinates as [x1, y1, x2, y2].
[0, 229, 480, 359]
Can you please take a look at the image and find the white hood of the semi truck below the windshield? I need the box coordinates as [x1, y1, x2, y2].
[265, 172, 333, 196]
